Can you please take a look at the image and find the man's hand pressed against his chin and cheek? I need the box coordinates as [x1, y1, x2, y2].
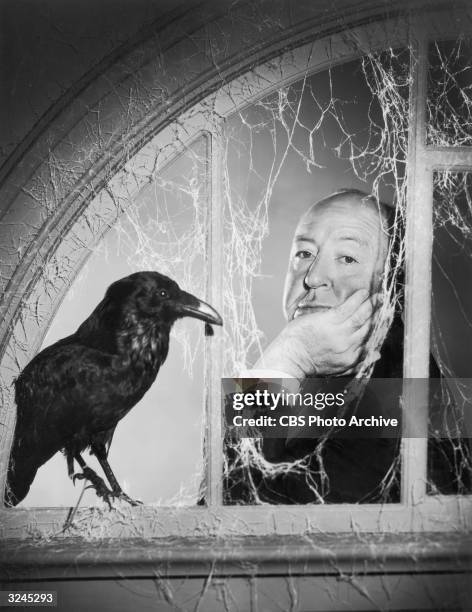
[254, 289, 375, 379]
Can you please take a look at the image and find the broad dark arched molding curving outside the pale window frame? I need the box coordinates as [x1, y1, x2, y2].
[0, 0, 458, 346]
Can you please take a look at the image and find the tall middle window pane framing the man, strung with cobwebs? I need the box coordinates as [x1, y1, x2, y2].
[224, 50, 409, 504]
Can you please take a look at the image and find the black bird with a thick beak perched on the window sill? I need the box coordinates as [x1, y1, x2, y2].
[5, 272, 222, 506]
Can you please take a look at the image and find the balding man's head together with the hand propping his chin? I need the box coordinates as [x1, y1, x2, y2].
[255, 189, 401, 379]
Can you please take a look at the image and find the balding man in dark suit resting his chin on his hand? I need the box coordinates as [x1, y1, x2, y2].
[225, 189, 403, 503]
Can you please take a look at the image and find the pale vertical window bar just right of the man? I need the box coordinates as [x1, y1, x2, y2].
[402, 22, 433, 506]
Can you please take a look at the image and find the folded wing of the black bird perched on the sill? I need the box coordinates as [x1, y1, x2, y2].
[6, 337, 128, 504]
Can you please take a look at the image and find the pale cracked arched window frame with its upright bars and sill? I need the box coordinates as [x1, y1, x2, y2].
[0, 13, 472, 538]
